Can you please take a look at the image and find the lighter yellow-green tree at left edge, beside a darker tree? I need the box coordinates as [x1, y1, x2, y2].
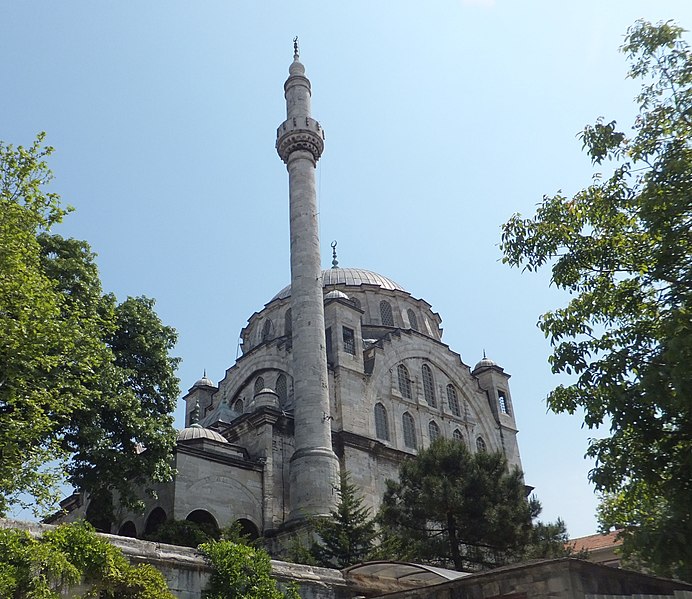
[0, 135, 98, 513]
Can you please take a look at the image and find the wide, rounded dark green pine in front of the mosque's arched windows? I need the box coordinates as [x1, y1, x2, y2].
[378, 438, 552, 570]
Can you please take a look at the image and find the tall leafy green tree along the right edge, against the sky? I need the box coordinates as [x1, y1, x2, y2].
[502, 21, 692, 580]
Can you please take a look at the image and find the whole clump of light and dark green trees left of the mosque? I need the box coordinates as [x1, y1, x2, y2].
[0, 134, 178, 514]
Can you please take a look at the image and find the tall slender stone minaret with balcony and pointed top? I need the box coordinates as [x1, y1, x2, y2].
[276, 38, 339, 520]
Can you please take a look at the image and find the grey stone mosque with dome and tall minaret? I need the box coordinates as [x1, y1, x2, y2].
[60, 48, 521, 538]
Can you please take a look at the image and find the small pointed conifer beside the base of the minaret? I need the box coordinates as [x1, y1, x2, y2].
[310, 470, 377, 570]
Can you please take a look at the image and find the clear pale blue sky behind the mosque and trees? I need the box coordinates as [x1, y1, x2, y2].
[0, 0, 692, 536]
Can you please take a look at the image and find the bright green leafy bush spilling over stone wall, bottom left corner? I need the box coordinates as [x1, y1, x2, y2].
[0, 523, 173, 599]
